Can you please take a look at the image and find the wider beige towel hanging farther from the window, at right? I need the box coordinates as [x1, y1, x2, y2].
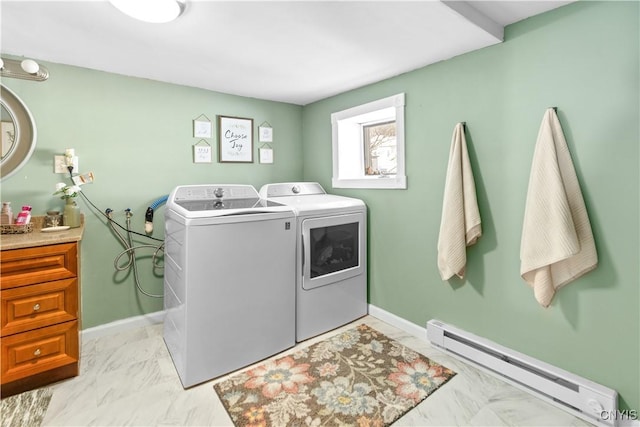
[520, 108, 598, 307]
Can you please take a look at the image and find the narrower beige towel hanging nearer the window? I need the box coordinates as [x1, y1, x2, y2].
[438, 123, 482, 280]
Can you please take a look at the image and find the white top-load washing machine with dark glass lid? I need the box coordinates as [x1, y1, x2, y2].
[164, 185, 295, 388]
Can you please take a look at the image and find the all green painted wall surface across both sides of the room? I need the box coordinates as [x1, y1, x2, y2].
[1, 2, 640, 409]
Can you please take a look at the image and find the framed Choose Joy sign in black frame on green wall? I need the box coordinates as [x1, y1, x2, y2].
[218, 116, 253, 163]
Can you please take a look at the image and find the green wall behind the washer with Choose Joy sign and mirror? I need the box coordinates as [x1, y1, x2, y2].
[2, 63, 302, 328]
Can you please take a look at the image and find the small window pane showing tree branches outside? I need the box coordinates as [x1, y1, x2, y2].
[362, 120, 398, 175]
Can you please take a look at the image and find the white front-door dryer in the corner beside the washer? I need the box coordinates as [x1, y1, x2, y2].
[260, 182, 367, 342]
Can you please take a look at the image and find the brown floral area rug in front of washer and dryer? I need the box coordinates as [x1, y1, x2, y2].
[214, 325, 455, 427]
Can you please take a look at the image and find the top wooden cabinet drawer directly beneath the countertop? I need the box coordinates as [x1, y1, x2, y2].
[0, 243, 78, 289]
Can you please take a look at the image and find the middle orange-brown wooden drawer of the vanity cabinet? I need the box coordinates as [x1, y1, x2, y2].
[0, 278, 78, 337]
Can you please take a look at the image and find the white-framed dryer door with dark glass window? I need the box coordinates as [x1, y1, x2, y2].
[302, 212, 366, 289]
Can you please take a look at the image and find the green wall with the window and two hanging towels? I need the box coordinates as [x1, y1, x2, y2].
[303, 2, 640, 409]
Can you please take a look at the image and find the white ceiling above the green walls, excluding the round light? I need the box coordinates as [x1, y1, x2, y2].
[0, 0, 571, 105]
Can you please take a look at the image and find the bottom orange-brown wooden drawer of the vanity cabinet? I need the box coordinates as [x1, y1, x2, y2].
[0, 320, 78, 384]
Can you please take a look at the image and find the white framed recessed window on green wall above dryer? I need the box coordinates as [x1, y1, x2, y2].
[331, 93, 407, 189]
